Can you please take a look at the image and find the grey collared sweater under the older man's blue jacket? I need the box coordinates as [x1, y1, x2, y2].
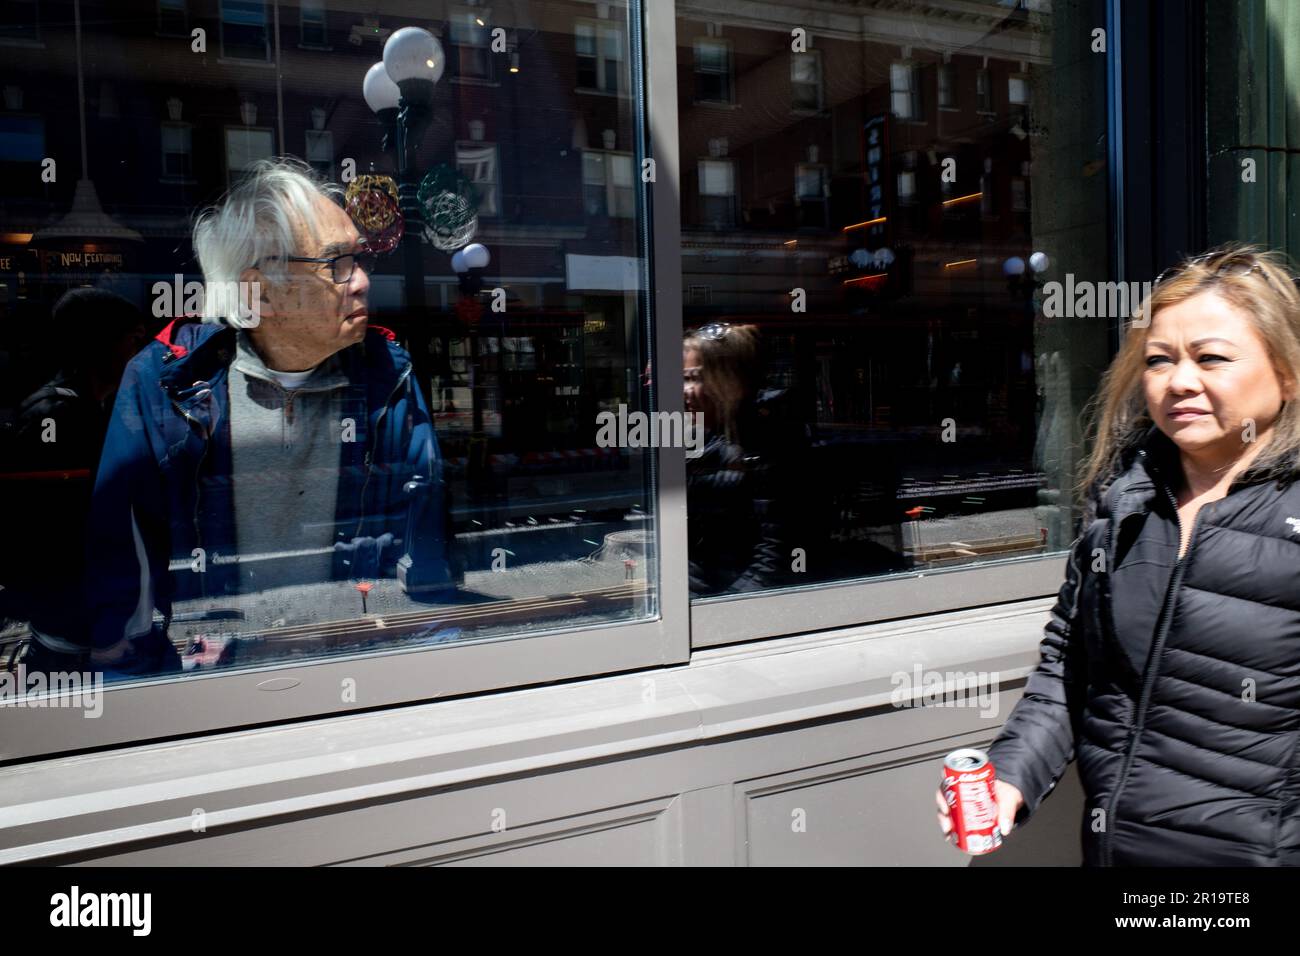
[230, 329, 348, 593]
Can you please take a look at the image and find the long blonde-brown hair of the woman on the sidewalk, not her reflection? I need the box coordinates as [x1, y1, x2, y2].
[1076, 245, 1300, 503]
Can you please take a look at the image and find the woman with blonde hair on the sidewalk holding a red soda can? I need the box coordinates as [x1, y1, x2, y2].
[940, 248, 1300, 866]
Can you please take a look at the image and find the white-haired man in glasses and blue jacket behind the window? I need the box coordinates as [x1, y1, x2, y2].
[88, 159, 450, 674]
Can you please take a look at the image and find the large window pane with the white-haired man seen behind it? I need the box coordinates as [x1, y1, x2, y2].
[0, 0, 659, 679]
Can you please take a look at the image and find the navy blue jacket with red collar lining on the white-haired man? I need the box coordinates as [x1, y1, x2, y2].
[86, 320, 451, 658]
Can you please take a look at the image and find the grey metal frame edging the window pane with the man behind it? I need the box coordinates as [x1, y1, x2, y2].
[0, 4, 690, 763]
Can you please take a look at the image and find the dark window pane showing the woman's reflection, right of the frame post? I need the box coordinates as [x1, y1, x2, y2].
[677, 0, 1122, 600]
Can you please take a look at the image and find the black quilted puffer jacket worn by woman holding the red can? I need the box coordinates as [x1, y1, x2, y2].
[989, 427, 1300, 866]
